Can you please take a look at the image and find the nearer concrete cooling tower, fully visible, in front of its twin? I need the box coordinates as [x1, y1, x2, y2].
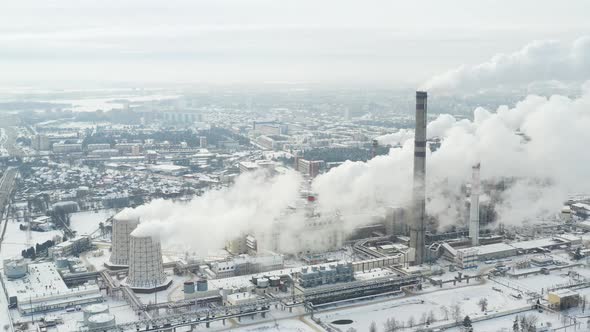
[125, 235, 172, 293]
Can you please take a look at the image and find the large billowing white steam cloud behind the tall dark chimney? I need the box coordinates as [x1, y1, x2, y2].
[313, 84, 590, 225]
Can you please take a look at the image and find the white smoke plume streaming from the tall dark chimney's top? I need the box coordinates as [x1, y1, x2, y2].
[422, 36, 590, 93]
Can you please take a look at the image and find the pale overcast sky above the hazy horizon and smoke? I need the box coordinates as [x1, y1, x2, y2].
[0, 0, 590, 86]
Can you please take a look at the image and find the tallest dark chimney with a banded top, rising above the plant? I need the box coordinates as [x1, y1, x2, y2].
[410, 91, 428, 265]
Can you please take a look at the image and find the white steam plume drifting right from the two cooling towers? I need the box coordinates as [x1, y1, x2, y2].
[121, 171, 301, 252]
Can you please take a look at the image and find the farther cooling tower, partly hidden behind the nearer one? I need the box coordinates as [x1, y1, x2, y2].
[107, 212, 139, 267]
